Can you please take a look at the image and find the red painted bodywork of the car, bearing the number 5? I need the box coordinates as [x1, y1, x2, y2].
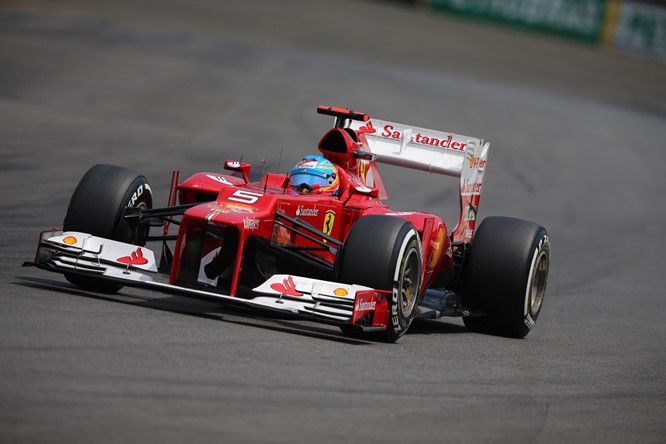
[170, 112, 453, 296]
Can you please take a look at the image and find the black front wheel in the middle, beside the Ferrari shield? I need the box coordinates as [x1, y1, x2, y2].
[336, 216, 422, 342]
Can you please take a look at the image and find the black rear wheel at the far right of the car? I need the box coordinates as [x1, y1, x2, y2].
[462, 216, 550, 338]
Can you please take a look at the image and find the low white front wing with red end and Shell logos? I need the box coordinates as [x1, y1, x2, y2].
[31, 230, 391, 331]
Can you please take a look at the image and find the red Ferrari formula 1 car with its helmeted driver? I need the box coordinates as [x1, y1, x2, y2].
[28, 107, 550, 341]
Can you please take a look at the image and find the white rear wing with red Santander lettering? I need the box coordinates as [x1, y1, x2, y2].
[348, 119, 490, 242]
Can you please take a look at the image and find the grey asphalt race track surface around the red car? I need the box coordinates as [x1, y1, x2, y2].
[0, 0, 666, 443]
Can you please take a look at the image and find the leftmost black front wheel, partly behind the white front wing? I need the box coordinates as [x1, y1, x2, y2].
[63, 164, 153, 293]
